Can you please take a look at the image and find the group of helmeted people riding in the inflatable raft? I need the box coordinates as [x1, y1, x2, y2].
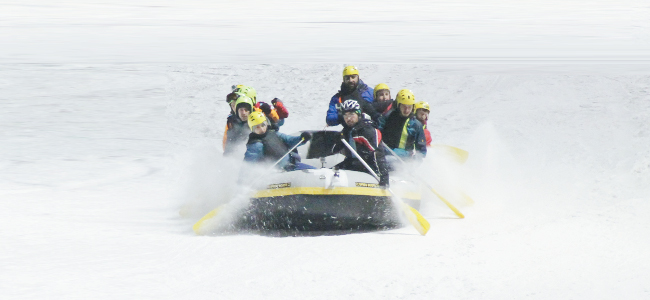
[223, 66, 431, 186]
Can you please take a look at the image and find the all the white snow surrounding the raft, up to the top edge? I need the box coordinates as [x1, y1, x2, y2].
[0, 1, 650, 299]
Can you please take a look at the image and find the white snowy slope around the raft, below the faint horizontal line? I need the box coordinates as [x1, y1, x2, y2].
[0, 64, 650, 299]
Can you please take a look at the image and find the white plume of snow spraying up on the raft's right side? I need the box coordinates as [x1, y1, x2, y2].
[406, 122, 526, 218]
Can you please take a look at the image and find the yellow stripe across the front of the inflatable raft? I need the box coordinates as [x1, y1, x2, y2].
[253, 187, 390, 198]
